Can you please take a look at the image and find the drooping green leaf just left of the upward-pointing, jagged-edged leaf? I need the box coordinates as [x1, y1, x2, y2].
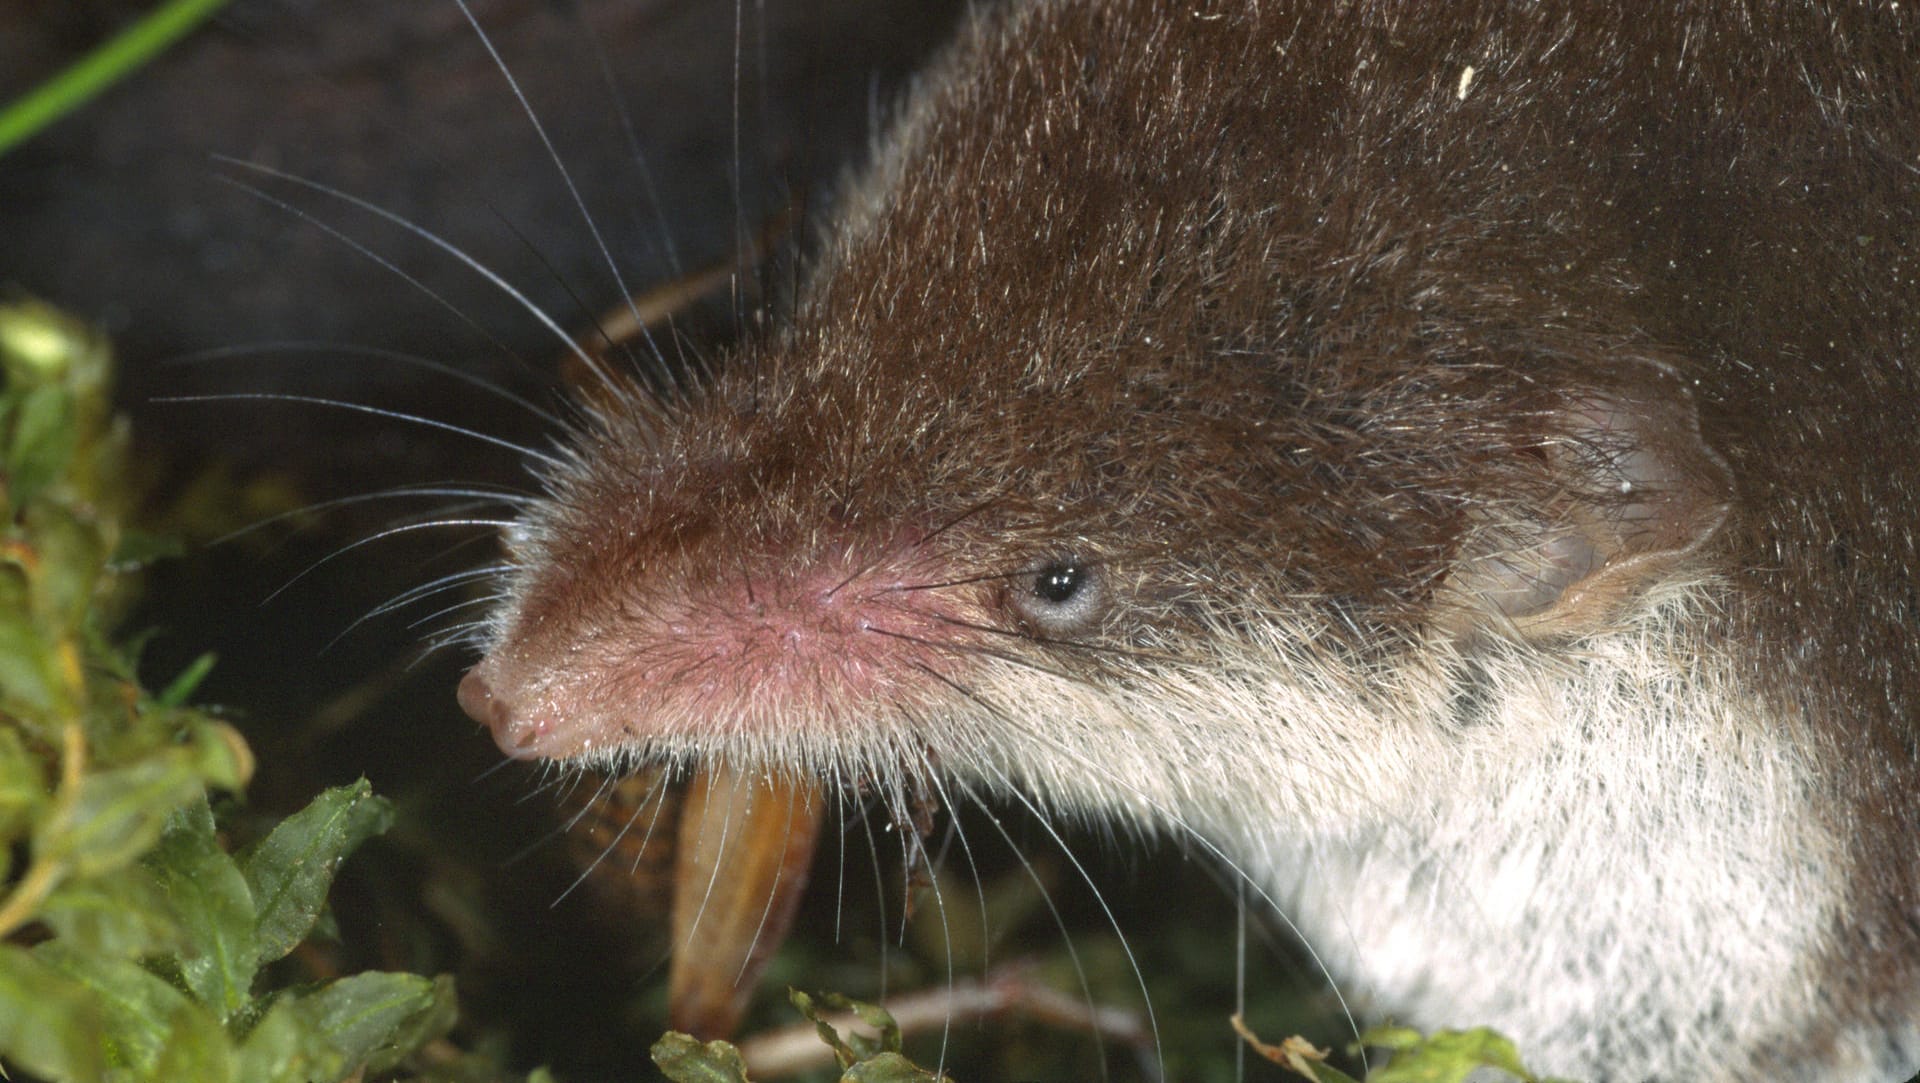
[148, 799, 259, 1022]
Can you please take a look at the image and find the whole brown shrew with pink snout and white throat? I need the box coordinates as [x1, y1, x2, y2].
[461, 0, 1920, 1079]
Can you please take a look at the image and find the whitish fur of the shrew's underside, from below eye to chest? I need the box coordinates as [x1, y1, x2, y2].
[948, 590, 1884, 1081]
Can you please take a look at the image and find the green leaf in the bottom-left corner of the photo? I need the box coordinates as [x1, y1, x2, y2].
[0, 947, 106, 1083]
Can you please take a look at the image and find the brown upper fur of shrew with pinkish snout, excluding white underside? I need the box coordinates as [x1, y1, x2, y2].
[463, 0, 1920, 1071]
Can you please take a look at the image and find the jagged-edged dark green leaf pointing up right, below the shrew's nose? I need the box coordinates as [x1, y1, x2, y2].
[240, 780, 394, 962]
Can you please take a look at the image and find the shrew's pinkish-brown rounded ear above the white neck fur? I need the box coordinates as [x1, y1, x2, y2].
[1440, 361, 1732, 639]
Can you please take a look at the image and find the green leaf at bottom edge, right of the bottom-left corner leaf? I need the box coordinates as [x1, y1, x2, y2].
[33, 941, 230, 1083]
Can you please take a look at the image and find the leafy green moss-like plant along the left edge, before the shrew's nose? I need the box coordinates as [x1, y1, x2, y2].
[0, 303, 468, 1083]
